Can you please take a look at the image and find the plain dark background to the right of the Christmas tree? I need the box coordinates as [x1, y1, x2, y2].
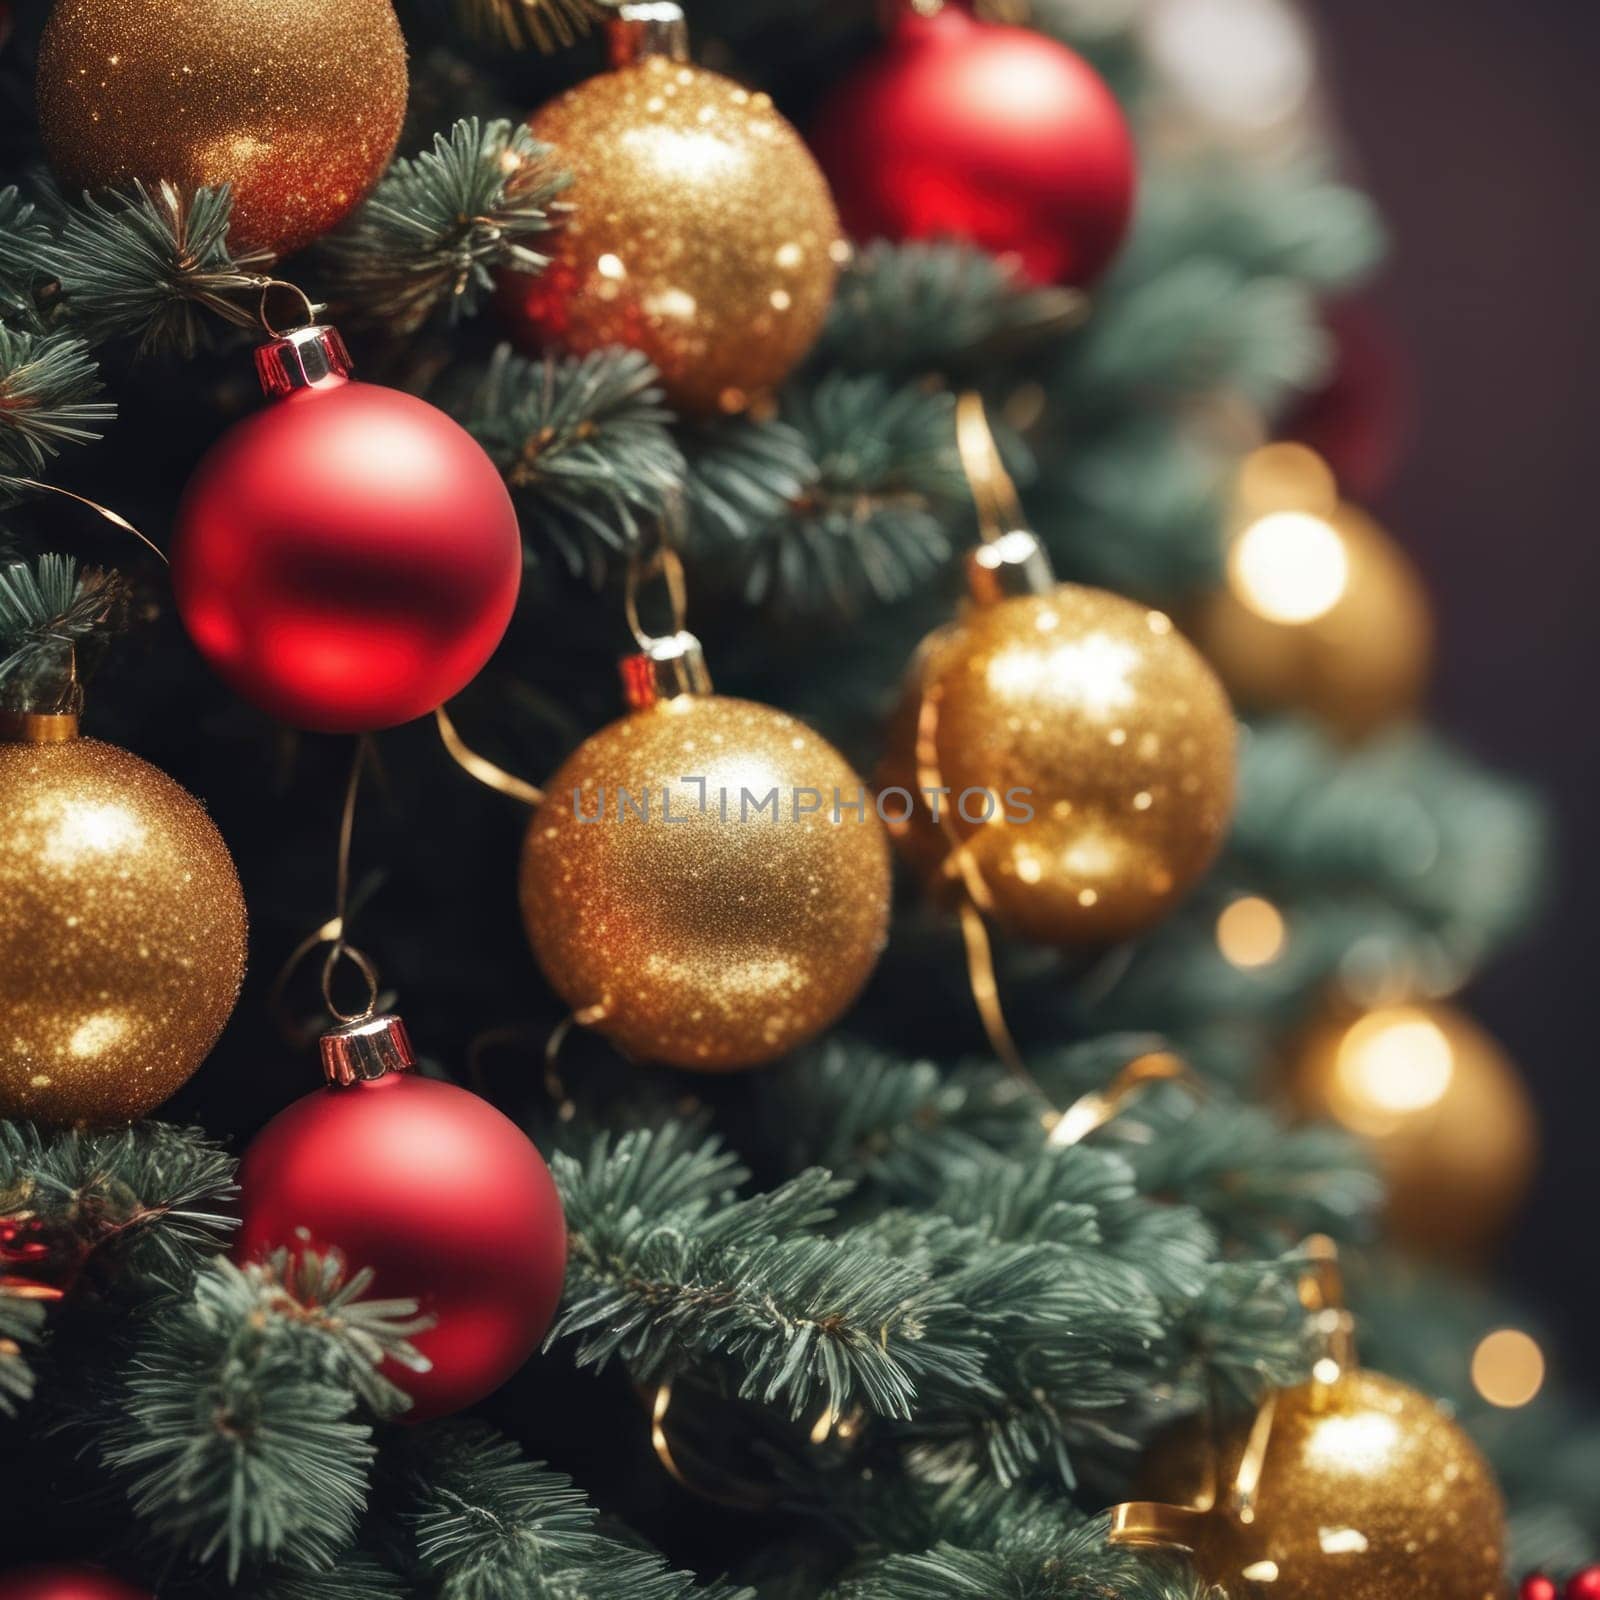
[1315, 0, 1600, 1382]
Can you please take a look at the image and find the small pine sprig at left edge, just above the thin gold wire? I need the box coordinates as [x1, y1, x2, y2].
[0, 323, 115, 480]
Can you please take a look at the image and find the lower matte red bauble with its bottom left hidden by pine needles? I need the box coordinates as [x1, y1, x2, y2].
[237, 1016, 566, 1421]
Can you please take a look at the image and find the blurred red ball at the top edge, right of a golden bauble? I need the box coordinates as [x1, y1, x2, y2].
[811, 0, 1138, 285]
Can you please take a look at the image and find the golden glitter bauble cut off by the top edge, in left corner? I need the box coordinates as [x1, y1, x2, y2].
[38, 0, 408, 256]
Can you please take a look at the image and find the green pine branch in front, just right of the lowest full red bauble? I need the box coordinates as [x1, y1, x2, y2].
[552, 1125, 981, 1418]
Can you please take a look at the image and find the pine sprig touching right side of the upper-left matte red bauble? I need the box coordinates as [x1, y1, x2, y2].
[459, 344, 685, 581]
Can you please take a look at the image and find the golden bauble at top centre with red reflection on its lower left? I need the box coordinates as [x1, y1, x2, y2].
[502, 56, 840, 411]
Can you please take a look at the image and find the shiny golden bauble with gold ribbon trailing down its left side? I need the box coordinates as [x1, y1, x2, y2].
[878, 584, 1235, 944]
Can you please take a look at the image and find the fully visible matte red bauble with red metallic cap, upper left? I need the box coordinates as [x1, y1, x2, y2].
[173, 326, 522, 733]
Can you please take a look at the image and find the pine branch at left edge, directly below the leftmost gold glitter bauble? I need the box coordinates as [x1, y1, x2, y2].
[0, 1122, 235, 1294]
